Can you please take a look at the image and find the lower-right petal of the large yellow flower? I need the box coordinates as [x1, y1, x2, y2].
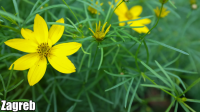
[48, 55, 76, 73]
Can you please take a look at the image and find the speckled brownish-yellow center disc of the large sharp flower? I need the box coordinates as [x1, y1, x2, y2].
[37, 43, 51, 57]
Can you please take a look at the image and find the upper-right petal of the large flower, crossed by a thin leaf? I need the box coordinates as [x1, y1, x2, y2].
[49, 18, 65, 45]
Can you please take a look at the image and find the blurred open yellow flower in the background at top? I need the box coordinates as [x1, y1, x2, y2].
[109, 0, 151, 33]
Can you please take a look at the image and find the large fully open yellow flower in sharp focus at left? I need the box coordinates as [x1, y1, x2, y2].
[5, 14, 81, 86]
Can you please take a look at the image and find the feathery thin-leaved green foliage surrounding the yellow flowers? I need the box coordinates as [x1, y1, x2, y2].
[0, 0, 200, 112]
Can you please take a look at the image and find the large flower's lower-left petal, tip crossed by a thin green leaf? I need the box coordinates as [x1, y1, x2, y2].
[9, 53, 40, 70]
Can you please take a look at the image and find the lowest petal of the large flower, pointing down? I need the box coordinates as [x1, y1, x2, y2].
[28, 58, 47, 86]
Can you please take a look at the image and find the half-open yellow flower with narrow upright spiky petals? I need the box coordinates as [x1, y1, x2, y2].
[89, 21, 111, 41]
